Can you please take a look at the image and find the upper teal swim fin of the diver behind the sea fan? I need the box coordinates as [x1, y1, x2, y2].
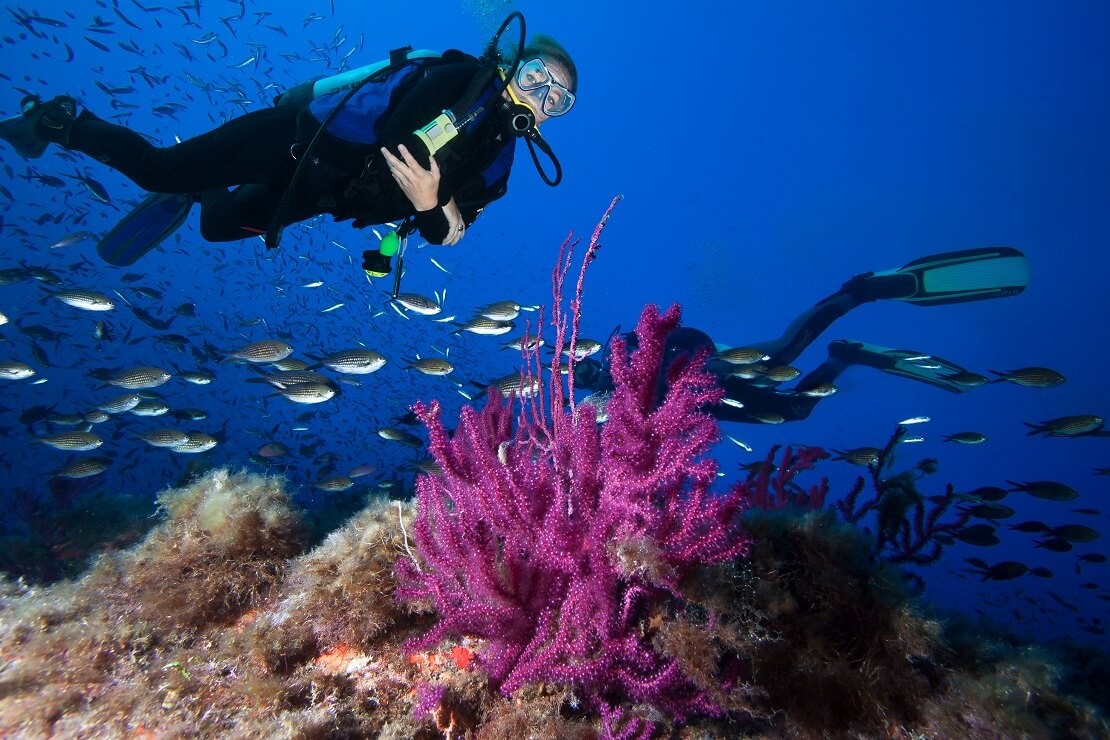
[861, 246, 1029, 306]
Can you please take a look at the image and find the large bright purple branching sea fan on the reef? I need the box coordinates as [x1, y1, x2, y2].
[397, 199, 747, 719]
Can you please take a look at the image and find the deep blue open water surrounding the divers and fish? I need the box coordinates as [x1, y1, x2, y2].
[0, 0, 1110, 647]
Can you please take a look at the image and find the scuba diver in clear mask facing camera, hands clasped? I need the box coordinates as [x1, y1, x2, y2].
[0, 12, 578, 270]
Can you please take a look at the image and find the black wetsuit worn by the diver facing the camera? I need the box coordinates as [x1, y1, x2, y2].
[68, 51, 514, 243]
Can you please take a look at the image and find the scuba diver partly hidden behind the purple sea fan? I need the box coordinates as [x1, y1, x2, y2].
[574, 246, 1029, 424]
